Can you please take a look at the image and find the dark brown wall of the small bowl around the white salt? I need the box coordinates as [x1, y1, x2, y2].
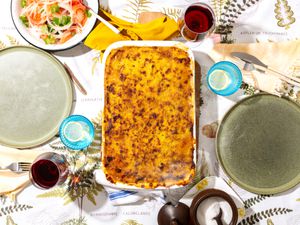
[190, 189, 238, 225]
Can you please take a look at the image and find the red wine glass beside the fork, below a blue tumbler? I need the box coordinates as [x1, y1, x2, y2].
[29, 152, 68, 189]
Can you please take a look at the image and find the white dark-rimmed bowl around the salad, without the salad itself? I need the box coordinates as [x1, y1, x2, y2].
[11, 0, 99, 51]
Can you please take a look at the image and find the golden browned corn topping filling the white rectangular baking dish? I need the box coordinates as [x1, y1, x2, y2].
[102, 46, 195, 188]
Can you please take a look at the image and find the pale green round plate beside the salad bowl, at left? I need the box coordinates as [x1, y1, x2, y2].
[0, 46, 73, 148]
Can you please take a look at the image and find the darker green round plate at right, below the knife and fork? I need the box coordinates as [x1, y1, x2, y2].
[216, 94, 300, 194]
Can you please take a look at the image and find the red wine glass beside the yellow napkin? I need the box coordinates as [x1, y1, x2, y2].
[180, 2, 215, 41]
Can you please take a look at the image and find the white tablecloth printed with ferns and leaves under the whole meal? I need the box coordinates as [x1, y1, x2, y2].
[0, 0, 300, 225]
